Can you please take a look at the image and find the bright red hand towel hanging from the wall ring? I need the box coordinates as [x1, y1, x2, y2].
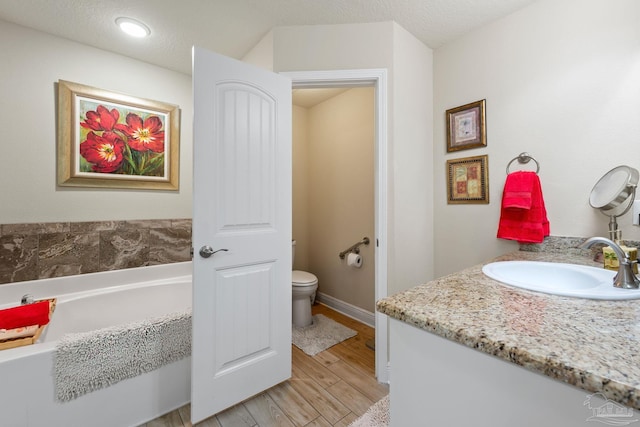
[498, 171, 549, 243]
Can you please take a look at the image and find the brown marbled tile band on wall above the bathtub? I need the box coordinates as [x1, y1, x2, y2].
[0, 219, 191, 284]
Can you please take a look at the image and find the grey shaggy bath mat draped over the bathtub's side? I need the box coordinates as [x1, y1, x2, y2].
[54, 310, 191, 402]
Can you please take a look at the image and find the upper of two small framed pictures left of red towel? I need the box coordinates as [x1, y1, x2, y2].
[446, 99, 487, 153]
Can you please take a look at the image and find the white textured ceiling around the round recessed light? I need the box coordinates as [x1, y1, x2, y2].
[0, 0, 536, 74]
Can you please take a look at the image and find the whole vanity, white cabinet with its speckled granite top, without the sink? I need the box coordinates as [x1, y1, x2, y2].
[376, 251, 640, 427]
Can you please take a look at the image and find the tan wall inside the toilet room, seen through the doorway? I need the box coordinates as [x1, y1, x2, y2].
[294, 88, 375, 312]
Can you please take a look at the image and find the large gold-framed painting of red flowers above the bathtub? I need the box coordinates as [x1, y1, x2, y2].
[58, 80, 180, 190]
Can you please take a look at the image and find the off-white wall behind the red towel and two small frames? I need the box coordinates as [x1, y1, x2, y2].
[433, 0, 640, 276]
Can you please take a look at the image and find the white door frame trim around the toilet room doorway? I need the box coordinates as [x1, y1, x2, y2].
[280, 68, 389, 383]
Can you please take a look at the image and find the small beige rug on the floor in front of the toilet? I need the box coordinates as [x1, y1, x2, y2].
[291, 314, 357, 356]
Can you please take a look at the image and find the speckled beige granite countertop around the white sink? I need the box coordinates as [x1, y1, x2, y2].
[377, 251, 640, 409]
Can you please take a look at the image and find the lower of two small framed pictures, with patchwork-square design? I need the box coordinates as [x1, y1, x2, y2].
[447, 154, 489, 204]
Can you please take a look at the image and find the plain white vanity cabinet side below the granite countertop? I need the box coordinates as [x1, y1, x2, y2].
[390, 319, 612, 427]
